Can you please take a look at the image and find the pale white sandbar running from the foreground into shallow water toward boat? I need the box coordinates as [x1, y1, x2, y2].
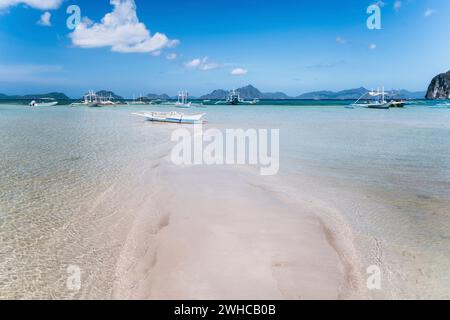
[114, 164, 365, 300]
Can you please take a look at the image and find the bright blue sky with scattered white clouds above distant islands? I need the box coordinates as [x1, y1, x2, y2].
[0, 0, 450, 98]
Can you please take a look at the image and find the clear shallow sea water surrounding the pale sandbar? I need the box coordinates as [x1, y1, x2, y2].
[0, 101, 450, 299]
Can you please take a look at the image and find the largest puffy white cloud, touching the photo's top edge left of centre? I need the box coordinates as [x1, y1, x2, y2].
[70, 0, 179, 53]
